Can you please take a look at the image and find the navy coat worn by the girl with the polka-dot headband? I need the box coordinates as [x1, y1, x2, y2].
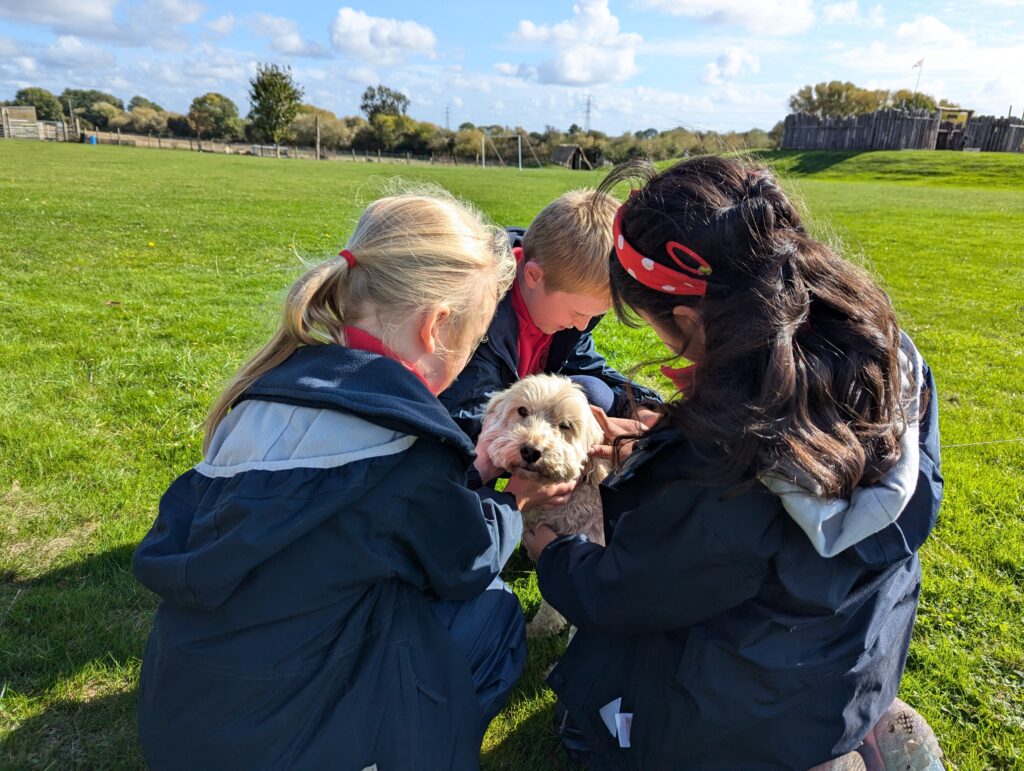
[537, 350, 942, 771]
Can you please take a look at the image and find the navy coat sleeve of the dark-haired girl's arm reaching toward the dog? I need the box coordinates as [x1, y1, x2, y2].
[537, 482, 779, 634]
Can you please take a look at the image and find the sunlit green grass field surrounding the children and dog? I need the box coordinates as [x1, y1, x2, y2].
[0, 141, 1024, 769]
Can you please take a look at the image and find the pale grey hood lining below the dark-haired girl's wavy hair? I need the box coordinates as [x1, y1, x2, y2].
[761, 332, 925, 557]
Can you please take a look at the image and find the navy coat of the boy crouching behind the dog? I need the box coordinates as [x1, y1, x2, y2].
[437, 227, 662, 441]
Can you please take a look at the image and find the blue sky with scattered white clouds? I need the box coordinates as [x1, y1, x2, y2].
[0, 0, 1024, 134]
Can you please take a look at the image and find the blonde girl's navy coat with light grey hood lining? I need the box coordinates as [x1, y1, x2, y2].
[133, 345, 522, 771]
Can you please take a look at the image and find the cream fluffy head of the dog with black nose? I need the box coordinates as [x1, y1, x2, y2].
[480, 375, 603, 482]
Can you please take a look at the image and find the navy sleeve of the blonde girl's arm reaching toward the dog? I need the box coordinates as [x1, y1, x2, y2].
[394, 450, 522, 600]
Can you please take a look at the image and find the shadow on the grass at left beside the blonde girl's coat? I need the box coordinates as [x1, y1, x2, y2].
[0, 546, 149, 768]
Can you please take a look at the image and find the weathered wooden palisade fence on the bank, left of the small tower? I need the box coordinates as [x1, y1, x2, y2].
[782, 110, 939, 149]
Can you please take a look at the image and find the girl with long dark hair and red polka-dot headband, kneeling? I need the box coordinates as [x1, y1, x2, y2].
[524, 157, 942, 770]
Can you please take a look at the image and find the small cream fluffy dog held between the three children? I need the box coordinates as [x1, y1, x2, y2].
[480, 375, 608, 635]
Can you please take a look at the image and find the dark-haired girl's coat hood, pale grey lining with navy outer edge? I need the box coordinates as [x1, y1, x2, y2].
[761, 333, 941, 557]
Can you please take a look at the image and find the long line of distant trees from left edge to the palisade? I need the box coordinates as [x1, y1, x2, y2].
[8, 65, 796, 160]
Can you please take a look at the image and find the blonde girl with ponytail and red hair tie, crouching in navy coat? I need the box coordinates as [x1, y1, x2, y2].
[133, 194, 564, 769]
